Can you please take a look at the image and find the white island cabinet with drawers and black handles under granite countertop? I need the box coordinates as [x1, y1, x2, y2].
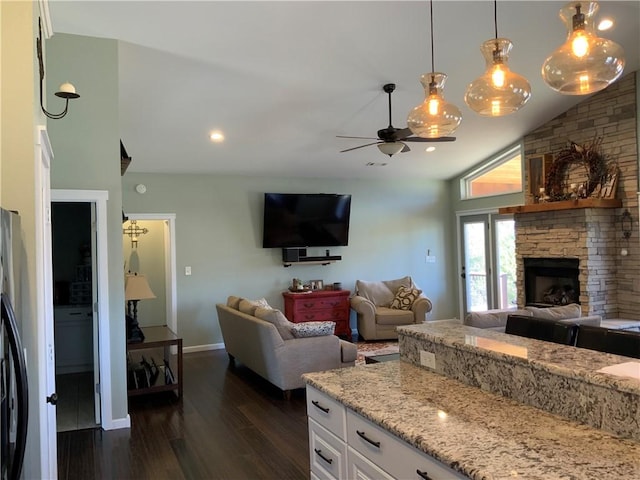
[307, 385, 467, 480]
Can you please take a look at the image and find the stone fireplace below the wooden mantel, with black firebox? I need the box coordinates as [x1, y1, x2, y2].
[514, 201, 619, 318]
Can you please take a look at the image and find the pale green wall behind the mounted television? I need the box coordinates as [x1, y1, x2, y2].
[122, 174, 456, 347]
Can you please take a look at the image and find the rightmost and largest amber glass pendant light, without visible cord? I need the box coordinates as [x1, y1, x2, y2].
[542, 2, 624, 95]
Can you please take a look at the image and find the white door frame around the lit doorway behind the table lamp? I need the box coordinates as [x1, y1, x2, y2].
[127, 212, 178, 334]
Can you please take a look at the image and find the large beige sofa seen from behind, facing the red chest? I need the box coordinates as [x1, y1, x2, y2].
[216, 297, 357, 397]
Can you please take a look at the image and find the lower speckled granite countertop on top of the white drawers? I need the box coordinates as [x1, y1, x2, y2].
[304, 361, 640, 480]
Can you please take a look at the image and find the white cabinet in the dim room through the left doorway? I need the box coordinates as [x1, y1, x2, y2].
[53, 305, 93, 374]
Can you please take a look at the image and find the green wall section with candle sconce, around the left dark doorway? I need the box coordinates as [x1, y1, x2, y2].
[46, 34, 127, 419]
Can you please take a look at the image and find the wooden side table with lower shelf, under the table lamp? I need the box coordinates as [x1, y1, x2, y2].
[127, 326, 182, 398]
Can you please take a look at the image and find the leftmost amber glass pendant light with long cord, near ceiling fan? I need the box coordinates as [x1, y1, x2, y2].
[407, 0, 462, 138]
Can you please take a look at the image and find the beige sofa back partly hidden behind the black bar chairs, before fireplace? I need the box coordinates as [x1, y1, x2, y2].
[463, 303, 602, 332]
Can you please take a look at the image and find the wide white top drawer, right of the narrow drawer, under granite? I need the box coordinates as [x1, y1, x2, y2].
[347, 410, 466, 480]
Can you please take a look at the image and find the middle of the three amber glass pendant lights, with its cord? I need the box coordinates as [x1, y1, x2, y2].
[464, 0, 531, 117]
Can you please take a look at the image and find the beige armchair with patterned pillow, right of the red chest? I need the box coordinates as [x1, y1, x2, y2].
[351, 276, 432, 340]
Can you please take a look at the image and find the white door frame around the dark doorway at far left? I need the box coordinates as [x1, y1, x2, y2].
[51, 189, 115, 430]
